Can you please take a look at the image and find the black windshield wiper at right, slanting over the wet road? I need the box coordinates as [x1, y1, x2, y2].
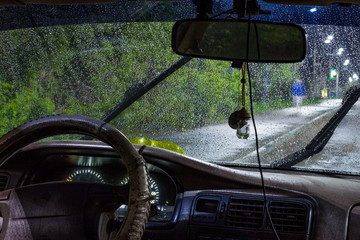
[270, 85, 360, 168]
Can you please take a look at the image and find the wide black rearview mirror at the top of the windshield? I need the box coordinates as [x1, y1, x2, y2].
[171, 20, 306, 63]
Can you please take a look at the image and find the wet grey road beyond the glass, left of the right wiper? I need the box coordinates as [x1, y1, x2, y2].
[155, 99, 341, 163]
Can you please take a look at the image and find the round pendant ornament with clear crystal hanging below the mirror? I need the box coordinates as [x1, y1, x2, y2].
[228, 63, 250, 139]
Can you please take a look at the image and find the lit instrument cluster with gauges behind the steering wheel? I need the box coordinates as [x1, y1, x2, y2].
[25, 155, 177, 222]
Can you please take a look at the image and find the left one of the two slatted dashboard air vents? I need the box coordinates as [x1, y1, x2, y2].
[226, 198, 264, 229]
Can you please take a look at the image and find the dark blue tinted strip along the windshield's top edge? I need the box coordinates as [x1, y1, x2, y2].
[0, 0, 360, 30]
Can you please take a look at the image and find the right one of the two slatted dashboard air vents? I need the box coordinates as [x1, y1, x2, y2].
[268, 201, 309, 233]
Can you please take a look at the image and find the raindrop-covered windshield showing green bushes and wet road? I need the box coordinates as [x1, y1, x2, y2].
[0, 1, 360, 174]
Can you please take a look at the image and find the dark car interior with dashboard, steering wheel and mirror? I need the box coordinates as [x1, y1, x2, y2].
[0, 0, 360, 240]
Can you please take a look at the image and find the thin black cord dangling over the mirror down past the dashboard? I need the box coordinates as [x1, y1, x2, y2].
[243, 11, 280, 240]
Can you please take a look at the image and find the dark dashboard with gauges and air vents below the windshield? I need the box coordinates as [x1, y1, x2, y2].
[0, 141, 360, 240]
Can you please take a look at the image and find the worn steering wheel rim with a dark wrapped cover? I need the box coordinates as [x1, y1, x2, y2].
[0, 115, 151, 240]
